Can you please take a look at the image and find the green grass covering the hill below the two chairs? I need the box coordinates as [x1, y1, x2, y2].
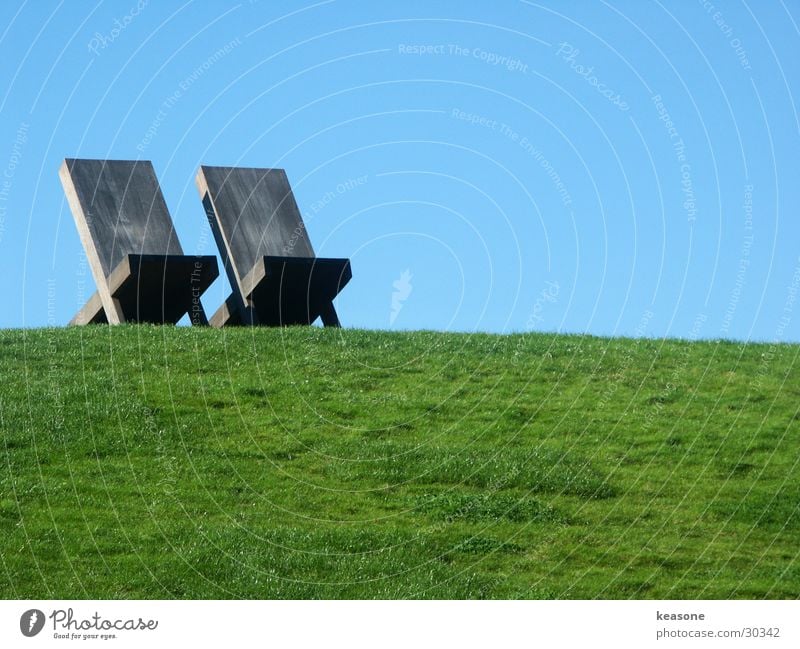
[0, 326, 800, 599]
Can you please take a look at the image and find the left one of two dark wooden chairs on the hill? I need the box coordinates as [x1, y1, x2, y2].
[59, 158, 219, 325]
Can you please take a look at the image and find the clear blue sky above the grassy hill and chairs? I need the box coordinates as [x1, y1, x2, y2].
[0, 0, 800, 341]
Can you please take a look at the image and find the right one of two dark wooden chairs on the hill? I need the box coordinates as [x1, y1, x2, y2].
[197, 166, 352, 327]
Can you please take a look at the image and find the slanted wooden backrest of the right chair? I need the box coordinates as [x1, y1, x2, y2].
[197, 165, 315, 281]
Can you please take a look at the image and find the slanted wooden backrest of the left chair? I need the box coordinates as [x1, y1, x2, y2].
[59, 158, 183, 282]
